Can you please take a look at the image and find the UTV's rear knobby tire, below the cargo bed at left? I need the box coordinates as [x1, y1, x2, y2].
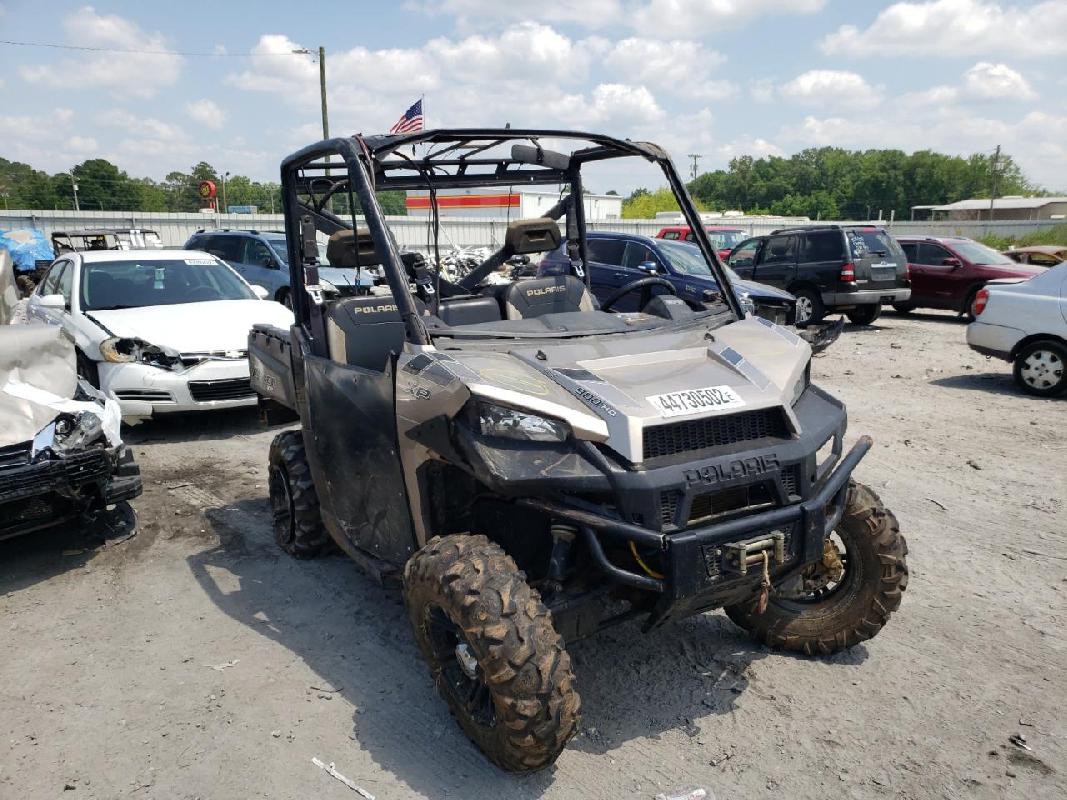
[269, 431, 330, 558]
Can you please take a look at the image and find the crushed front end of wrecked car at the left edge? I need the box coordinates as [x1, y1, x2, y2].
[0, 325, 141, 539]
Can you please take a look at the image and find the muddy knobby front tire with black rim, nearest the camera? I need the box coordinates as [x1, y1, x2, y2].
[403, 534, 580, 772]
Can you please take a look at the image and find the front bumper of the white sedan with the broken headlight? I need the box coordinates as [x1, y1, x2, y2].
[97, 358, 256, 417]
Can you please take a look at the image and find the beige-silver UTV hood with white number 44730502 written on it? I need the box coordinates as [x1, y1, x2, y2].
[433, 318, 811, 463]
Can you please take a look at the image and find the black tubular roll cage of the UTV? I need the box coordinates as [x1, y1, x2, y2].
[282, 128, 744, 345]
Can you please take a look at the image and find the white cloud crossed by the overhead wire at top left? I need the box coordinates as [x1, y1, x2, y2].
[18, 5, 184, 97]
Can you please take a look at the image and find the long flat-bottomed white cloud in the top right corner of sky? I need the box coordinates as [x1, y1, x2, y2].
[821, 0, 1067, 59]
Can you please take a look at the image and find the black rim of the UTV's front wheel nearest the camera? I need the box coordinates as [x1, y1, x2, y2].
[424, 606, 496, 729]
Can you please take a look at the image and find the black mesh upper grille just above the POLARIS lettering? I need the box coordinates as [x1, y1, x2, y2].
[642, 407, 790, 461]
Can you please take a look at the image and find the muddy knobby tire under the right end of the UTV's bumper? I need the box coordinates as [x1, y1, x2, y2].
[726, 481, 908, 655]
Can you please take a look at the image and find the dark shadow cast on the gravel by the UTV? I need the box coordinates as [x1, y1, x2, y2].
[188, 498, 866, 798]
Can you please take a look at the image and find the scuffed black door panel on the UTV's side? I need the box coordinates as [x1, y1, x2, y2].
[301, 355, 417, 565]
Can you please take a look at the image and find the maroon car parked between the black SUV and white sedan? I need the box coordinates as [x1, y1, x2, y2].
[893, 236, 1045, 319]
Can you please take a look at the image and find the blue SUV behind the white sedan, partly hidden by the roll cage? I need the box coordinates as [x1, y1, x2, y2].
[185, 229, 377, 308]
